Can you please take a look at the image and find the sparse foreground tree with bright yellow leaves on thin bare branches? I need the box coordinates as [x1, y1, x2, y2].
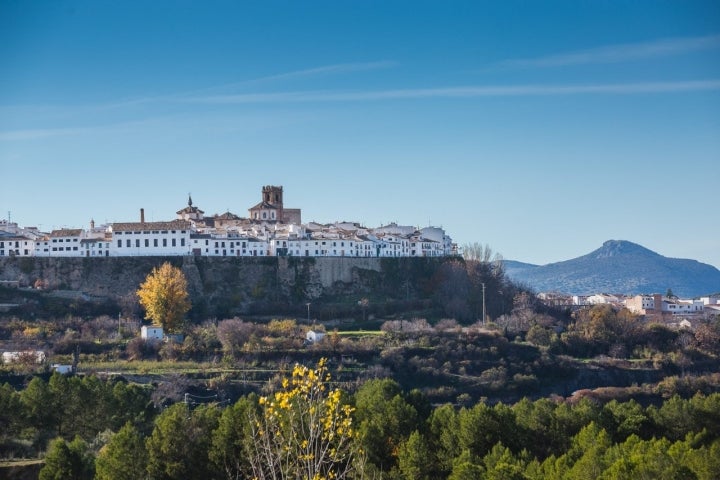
[249, 359, 363, 480]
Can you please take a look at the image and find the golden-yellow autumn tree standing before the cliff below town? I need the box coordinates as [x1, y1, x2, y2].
[137, 262, 190, 332]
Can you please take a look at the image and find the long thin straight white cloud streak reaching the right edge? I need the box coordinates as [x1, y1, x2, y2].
[183, 80, 720, 104]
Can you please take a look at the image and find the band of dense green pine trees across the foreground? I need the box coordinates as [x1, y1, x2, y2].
[0, 374, 720, 480]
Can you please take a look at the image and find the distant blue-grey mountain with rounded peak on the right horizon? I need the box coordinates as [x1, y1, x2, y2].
[505, 240, 720, 297]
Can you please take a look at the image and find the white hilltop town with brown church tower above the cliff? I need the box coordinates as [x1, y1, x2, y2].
[0, 186, 458, 257]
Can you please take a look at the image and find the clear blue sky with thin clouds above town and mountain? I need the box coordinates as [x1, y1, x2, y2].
[0, 0, 720, 267]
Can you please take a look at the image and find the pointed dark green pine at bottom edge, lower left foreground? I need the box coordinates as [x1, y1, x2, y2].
[95, 422, 147, 480]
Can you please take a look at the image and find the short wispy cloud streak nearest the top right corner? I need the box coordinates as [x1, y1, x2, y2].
[494, 35, 720, 68]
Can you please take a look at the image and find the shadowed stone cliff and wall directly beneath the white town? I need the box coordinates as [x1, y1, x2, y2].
[0, 257, 445, 315]
